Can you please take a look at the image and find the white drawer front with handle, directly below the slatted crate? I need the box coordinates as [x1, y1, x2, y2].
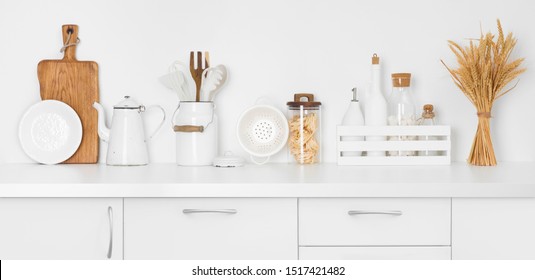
[299, 198, 451, 246]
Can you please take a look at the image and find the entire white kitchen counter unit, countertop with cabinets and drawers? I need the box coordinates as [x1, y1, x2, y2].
[0, 162, 535, 259]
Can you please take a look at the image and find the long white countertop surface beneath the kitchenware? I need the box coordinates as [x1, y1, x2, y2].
[0, 163, 535, 197]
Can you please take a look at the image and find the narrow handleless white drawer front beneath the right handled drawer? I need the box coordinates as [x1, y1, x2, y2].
[299, 246, 451, 260]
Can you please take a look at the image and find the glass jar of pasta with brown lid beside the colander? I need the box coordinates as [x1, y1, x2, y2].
[287, 93, 321, 164]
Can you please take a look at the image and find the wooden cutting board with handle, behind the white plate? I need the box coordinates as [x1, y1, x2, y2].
[37, 25, 99, 163]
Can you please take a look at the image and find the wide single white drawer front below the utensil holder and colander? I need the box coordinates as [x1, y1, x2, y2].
[124, 198, 298, 259]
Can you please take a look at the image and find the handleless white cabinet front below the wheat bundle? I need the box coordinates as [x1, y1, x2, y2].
[452, 198, 535, 260]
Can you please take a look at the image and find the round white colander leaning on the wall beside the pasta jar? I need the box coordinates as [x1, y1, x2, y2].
[238, 105, 289, 164]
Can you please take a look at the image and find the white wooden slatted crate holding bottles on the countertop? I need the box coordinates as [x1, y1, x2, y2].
[336, 125, 451, 165]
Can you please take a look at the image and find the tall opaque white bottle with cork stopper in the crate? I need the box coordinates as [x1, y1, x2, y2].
[364, 54, 388, 157]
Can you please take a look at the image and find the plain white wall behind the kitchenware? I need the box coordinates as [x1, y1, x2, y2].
[0, 0, 535, 162]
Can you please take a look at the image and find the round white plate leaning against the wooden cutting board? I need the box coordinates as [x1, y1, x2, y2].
[19, 100, 82, 164]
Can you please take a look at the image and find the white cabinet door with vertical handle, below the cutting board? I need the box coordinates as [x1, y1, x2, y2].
[0, 198, 123, 259]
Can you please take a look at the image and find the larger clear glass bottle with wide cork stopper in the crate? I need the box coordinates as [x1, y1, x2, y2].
[388, 73, 417, 156]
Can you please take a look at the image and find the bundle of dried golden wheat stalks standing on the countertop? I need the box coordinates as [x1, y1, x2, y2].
[441, 20, 526, 166]
